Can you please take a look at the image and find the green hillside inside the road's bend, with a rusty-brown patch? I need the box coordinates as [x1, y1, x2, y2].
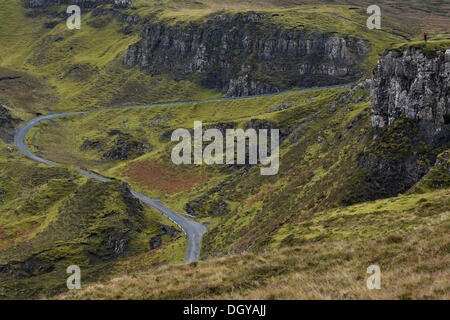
[29, 78, 448, 258]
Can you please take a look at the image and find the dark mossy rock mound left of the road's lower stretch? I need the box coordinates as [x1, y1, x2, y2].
[0, 180, 144, 284]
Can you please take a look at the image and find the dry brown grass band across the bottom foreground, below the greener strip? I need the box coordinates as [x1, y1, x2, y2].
[58, 230, 450, 299]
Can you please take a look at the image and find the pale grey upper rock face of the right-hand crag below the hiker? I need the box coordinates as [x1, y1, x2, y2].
[371, 48, 450, 145]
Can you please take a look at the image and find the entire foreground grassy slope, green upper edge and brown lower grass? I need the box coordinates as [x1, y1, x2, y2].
[57, 191, 450, 299]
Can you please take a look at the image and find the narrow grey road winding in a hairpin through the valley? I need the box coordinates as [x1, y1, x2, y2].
[14, 84, 349, 263]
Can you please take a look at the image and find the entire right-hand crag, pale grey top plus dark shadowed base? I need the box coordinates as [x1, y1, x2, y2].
[346, 44, 450, 202]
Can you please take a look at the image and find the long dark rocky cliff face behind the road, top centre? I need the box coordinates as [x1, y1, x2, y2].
[124, 12, 368, 96]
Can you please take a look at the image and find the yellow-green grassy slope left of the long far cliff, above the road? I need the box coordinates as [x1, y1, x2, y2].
[0, 0, 220, 115]
